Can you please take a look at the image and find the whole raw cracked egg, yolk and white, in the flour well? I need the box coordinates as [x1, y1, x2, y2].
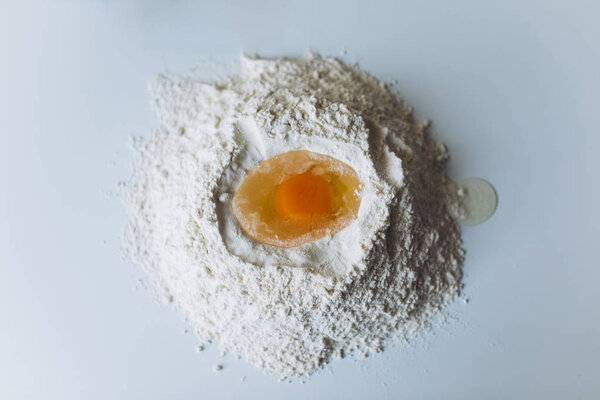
[232, 150, 362, 248]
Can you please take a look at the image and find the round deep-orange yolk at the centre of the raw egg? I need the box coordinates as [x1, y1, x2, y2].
[273, 172, 332, 222]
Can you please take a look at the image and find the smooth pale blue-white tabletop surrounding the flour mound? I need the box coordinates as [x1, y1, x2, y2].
[0, 0, 600, 400]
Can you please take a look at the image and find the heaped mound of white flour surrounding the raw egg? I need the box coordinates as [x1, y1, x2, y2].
[126, 54, 463, 378]
